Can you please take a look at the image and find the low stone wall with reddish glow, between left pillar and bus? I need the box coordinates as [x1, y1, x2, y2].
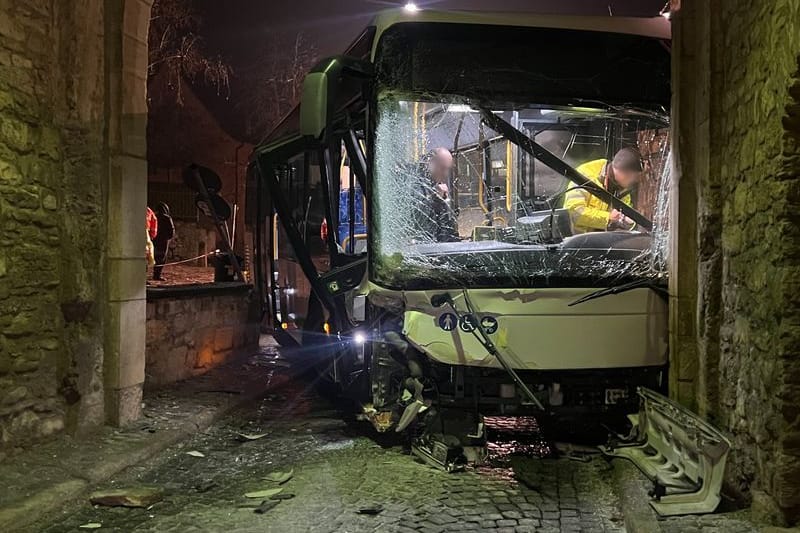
[145, 284, 259, 387]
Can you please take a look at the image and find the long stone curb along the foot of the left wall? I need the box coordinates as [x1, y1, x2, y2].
[0, 378, 269, 533]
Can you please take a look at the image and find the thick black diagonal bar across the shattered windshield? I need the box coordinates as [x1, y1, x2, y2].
[478, 106, 653, 231]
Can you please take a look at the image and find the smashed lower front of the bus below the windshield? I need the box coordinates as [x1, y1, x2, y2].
[336, 280, 667, 456]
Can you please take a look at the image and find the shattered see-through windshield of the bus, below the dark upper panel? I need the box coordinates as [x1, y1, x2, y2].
[372, 98, 670, 288]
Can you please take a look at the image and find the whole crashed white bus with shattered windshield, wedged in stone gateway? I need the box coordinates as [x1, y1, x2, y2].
[248, 10, 670, 464]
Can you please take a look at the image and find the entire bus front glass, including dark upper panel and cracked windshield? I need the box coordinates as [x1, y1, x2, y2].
[370, 23, 671, 289]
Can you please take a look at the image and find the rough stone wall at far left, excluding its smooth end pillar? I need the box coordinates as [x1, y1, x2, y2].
[0, 1, 105, 448]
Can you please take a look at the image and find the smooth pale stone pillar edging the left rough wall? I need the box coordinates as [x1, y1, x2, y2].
[104, 0, 151, 425]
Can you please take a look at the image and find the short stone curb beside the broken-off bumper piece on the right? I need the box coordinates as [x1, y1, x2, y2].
[611, 458, 661, 533]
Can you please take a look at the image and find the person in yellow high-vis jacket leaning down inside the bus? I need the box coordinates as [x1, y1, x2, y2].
[564, 148, 643, 233]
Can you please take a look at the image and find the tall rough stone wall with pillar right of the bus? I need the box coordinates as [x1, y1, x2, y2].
[673, 0, 800, 523]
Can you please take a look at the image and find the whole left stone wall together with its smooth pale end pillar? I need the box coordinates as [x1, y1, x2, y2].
[0, 0, 152, 457]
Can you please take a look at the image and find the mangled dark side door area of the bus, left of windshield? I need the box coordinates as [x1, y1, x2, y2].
[259, 133, 367, 344]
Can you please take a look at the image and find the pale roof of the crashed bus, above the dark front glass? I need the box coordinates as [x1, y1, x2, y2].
[260, 8, 671, 146]
